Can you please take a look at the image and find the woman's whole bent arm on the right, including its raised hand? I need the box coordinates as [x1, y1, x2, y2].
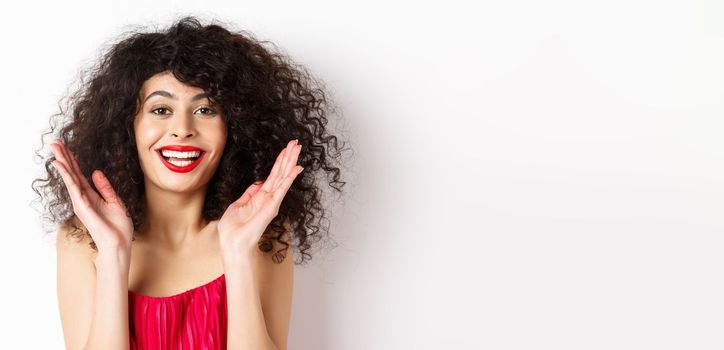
[217, 140, 304, 350]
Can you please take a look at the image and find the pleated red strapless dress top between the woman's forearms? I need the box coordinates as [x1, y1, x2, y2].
[128, 274, 227, 350]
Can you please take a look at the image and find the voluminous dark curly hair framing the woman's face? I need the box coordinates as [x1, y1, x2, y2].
[32, 16, 346, 263]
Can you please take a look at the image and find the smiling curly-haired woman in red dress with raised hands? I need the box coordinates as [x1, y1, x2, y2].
[33, 17, 345, 349]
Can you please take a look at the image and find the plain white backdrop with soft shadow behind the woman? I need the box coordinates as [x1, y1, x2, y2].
[0, 0, 724, 350]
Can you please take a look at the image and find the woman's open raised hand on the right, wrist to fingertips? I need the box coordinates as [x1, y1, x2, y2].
[217, 140, 304, 254]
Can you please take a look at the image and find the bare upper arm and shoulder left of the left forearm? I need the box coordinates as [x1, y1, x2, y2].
[56, 218, 96, 349]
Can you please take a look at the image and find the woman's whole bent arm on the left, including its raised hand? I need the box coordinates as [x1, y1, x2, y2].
[51, 140, 133, 350]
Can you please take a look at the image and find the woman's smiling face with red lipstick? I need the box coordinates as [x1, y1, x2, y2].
[133, 72, 227, 192]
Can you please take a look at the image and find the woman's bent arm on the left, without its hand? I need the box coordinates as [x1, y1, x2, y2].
[56, 220, 130, 350]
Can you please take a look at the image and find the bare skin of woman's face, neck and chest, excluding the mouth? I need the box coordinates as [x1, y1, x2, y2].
[129, 73, 227, 296]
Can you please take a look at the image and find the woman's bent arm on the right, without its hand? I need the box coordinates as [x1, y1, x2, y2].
[224, 230, 294, 350]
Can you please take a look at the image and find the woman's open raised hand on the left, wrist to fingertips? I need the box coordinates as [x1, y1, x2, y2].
[50, 140, 133, 253]
